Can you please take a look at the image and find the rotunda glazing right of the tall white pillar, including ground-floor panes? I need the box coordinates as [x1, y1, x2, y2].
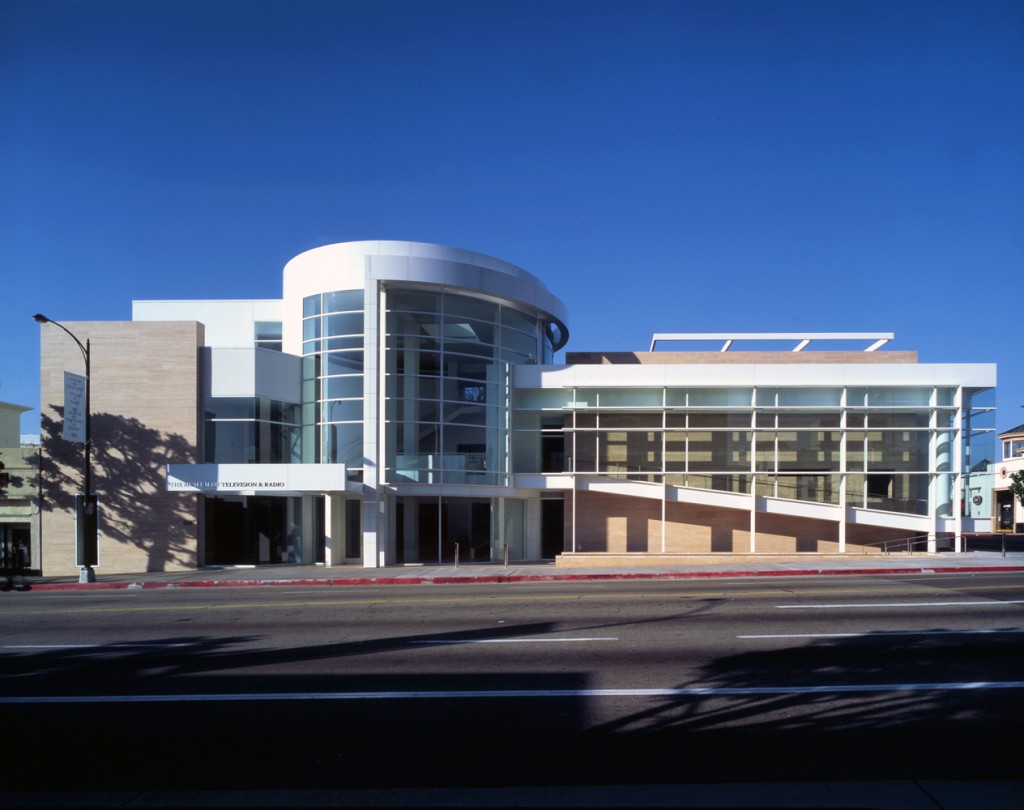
[384, 288, 544, 562]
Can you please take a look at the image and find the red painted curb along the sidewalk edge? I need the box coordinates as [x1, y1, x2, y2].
[19, 565, 1024, 591]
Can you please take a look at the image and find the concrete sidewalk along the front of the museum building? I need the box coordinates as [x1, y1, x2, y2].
[19, 549, 1024, 591]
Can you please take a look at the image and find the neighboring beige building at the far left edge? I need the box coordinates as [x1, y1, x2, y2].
[0, 402, 40, 571]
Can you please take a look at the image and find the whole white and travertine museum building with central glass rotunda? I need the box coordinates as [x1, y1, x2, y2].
[36, 242, 995, 571]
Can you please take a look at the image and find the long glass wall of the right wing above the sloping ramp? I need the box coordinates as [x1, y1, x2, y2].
[512, 387, 974, 516]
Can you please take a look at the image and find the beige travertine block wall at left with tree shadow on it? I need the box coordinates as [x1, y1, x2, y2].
[40, 322, 204, 579]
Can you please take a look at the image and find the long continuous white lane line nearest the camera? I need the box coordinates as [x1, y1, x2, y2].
[6, 681, 1024, 705]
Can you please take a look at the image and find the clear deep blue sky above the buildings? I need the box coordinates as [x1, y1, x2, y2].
[0, 0, 1024, 432]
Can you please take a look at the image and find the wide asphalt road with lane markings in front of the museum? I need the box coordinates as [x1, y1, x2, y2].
[0, 573, 1024, 791]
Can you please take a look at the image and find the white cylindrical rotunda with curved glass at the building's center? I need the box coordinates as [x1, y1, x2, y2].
[283, 242, 568, 564]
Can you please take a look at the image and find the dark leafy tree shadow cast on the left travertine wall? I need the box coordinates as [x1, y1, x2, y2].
[39, 404, 197, 571]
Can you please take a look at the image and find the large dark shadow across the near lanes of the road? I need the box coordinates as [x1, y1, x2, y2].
[0, 605, 1024, 788]
